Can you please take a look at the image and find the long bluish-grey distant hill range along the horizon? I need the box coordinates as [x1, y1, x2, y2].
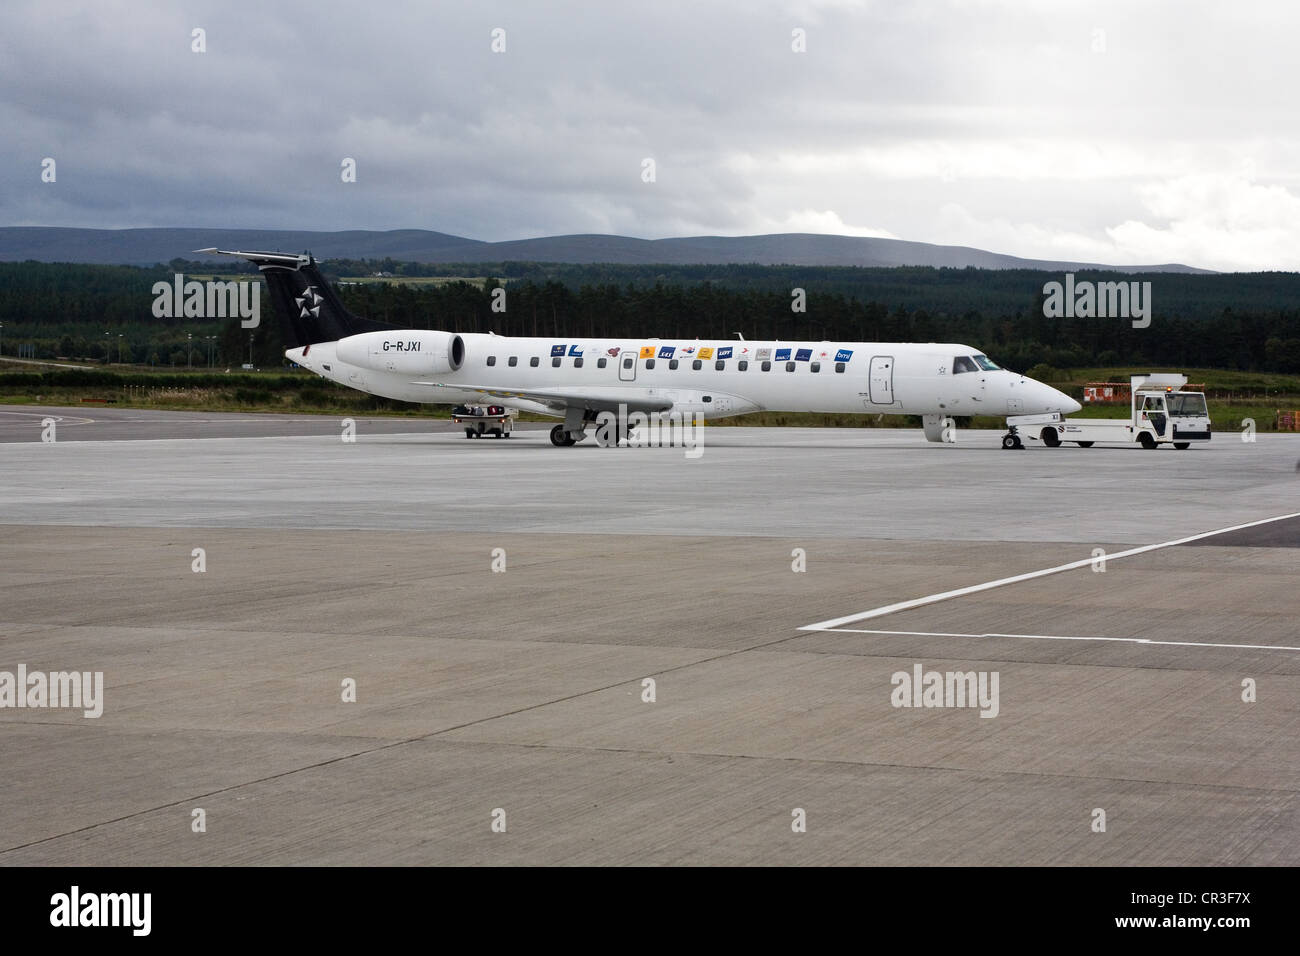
[0, 226, 1209, 273]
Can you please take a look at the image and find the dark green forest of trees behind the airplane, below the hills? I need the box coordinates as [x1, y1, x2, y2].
[0, 260, 1300, 372]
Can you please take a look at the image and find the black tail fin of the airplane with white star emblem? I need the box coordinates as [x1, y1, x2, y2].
[195, 248, 397, 349]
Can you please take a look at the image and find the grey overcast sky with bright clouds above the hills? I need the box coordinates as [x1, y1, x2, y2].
[0, 0, 1300, 271]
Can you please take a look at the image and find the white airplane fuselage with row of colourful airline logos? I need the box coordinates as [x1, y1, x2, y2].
[285, 329, 1079, 418]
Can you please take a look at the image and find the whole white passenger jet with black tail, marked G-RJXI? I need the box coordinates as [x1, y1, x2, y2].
[195, 248, 1082, 449]
